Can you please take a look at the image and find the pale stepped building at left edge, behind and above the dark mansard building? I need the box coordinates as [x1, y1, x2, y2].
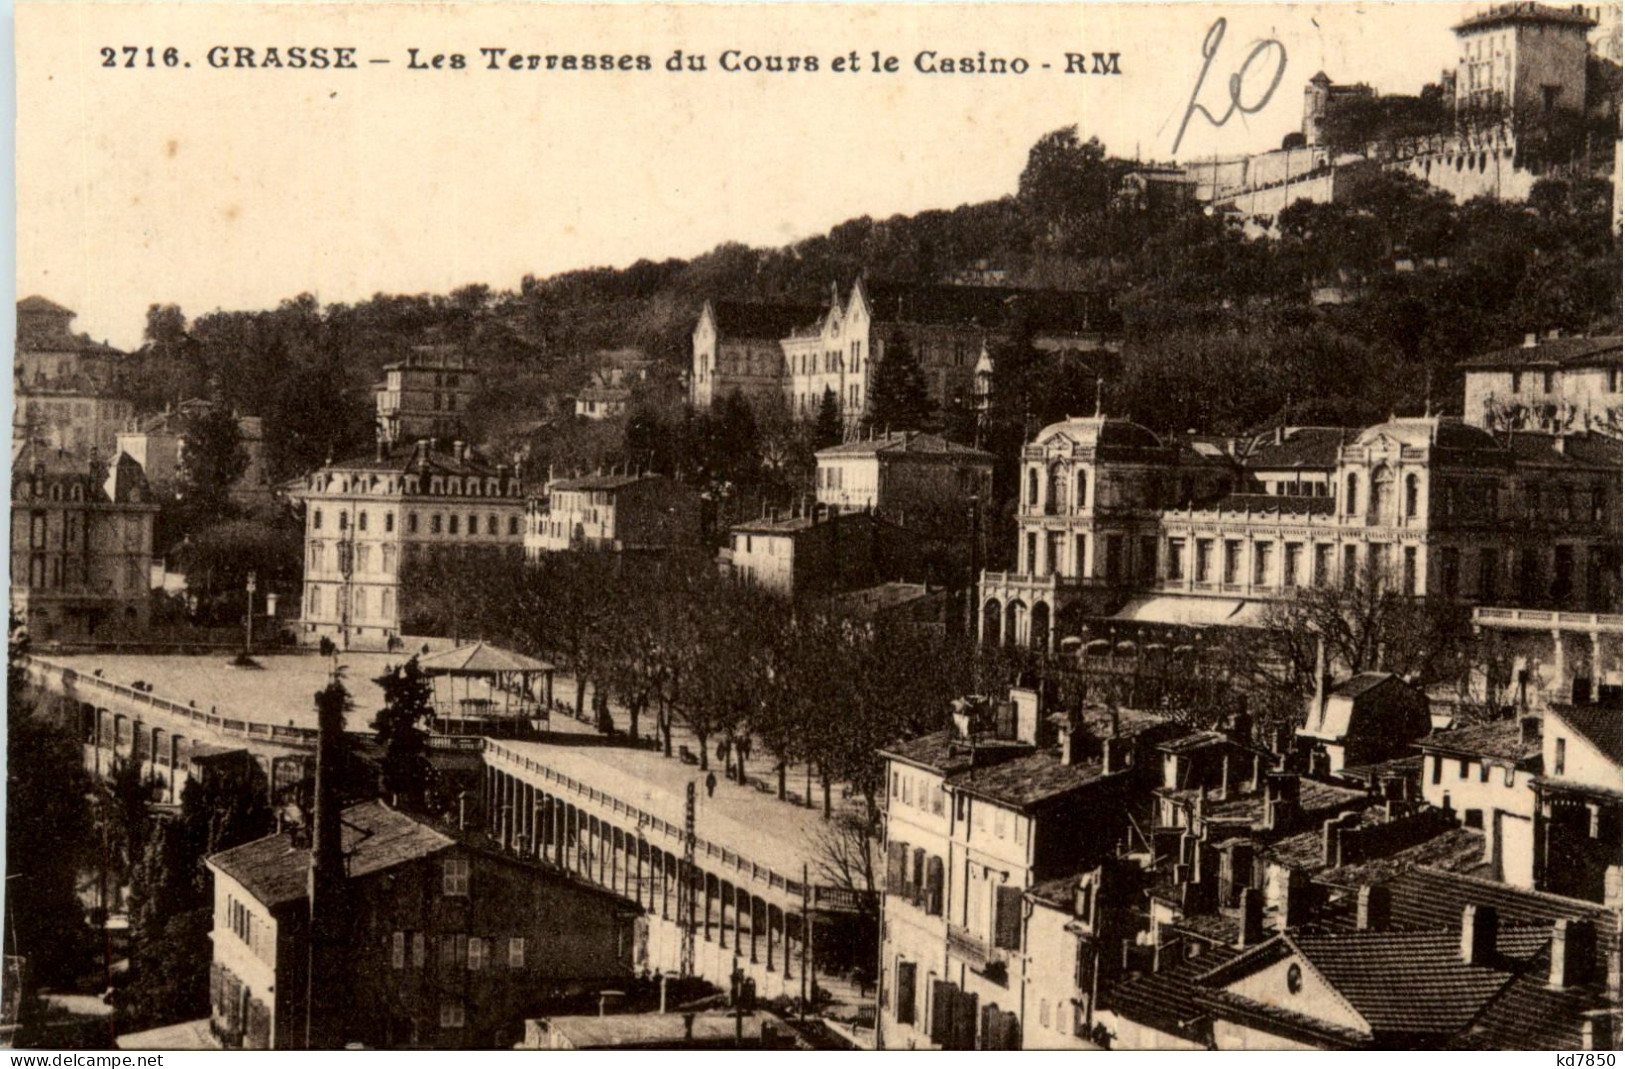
[11, 297, 135, 460]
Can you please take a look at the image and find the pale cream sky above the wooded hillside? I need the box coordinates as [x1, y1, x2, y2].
[16, 2, 1472, 348]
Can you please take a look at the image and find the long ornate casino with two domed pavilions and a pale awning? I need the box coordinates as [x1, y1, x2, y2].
[982, 418, 1620, 648]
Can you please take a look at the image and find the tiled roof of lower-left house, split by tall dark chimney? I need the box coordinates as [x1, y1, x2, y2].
[208, 801, 452, 908]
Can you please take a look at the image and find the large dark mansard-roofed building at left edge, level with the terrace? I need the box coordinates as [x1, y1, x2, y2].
[11, 444, 158, 642]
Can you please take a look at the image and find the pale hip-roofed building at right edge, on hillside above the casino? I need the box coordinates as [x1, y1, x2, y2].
[1461, 333, 1625, 437]
